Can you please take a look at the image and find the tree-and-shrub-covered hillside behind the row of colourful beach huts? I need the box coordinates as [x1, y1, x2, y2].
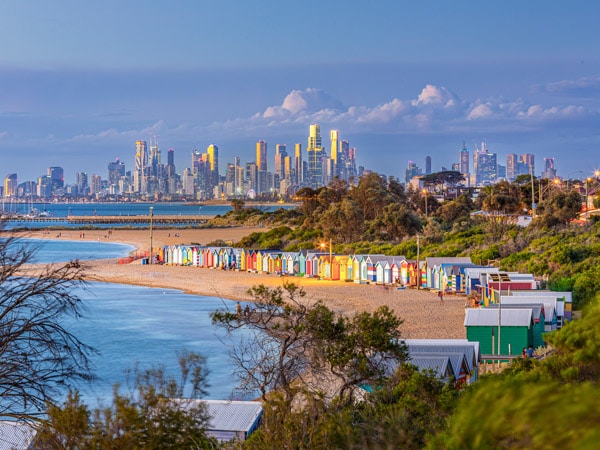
[213, 173, 600, 308]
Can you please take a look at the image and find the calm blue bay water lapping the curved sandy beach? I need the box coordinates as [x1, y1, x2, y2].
[19, 239, 246, 406]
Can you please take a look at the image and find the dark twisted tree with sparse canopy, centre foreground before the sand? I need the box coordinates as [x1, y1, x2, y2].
[212, 283, 406, 405]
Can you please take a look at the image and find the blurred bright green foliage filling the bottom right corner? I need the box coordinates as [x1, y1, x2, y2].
[429, 296, 600, 449]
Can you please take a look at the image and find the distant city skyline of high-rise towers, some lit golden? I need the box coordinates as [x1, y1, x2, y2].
[0, 123, 568, 201]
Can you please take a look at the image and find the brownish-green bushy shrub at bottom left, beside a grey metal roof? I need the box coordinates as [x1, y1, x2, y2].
[38, 351, 217, 449]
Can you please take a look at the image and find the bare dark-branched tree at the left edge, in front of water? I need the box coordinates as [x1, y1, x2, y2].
[0, 232, 93, 419]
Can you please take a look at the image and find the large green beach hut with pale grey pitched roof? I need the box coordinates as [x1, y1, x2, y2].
[464, 307, 533, 359]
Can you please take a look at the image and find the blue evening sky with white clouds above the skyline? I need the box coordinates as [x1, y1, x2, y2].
[0, 0, 600, 183]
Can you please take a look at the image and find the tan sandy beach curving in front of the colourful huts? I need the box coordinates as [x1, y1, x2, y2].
[11, 227, 465, 339]
